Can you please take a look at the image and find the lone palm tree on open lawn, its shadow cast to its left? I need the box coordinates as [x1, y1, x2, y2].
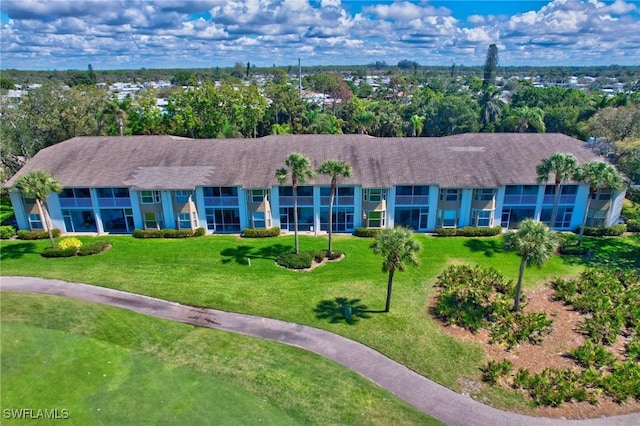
[371, 227, 422, 312]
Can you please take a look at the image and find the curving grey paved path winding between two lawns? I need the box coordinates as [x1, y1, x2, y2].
[0, 277, 640, 426]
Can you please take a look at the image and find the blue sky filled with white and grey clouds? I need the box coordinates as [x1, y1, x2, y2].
[0, 0, 640, 70]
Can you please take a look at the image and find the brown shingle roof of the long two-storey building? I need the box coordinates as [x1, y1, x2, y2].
[7, 133, 602, 189]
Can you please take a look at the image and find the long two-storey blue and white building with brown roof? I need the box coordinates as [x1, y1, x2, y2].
[6, 133, 624, 233]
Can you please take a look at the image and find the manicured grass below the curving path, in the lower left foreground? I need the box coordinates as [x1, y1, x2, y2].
[0, 292, 439, 425]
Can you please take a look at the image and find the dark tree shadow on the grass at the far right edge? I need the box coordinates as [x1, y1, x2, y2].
[562, 235, 640, 270]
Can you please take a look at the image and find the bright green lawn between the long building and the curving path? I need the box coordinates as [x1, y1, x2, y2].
[0, 235, 640, 408]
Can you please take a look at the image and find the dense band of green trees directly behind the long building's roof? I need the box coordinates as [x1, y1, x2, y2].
[0, 71, 640, 180]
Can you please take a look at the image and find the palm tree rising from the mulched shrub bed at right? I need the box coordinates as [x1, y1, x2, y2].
[504, 218, 558, 312]
